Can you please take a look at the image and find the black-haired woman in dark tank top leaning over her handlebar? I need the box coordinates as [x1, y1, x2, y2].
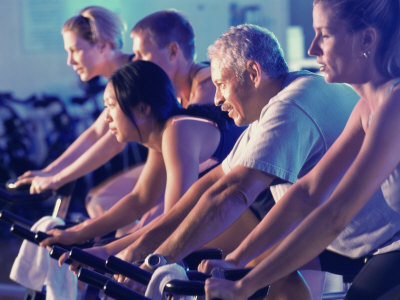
[42, 61, 242, 246]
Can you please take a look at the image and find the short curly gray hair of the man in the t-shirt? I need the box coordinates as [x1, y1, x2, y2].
[208, 24, 289, 80]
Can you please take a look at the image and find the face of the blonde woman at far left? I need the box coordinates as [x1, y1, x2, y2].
[62, 31, 104, 81]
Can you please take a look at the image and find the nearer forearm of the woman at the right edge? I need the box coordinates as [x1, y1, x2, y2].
[238, 168, 380, 291]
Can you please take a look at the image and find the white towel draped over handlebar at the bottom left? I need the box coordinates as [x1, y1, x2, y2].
[10, 216, 78, 300]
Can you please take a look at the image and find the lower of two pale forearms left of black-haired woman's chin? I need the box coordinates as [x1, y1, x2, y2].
[55, 132, 125, 186]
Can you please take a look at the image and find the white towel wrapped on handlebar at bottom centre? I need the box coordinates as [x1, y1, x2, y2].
[145, 264, 193, 300]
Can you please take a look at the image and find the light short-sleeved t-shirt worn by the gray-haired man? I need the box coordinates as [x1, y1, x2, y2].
[222, 71, 359, 193]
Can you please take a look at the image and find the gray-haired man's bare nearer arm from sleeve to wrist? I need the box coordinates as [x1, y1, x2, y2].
[155, 166, 275, 262]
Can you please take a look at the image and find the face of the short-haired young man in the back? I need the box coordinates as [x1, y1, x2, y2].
[131, 31, 172, 78]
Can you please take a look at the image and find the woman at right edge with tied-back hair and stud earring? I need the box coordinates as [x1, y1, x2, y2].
[206, 0, 400, 300]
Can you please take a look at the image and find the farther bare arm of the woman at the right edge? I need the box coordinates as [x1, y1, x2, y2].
[222, 99, 364, 266]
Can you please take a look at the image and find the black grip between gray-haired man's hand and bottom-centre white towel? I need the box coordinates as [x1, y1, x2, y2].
[106, 255, 151, 285]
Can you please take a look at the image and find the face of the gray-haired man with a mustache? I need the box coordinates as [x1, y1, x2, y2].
[211, 59, 252, 126]
